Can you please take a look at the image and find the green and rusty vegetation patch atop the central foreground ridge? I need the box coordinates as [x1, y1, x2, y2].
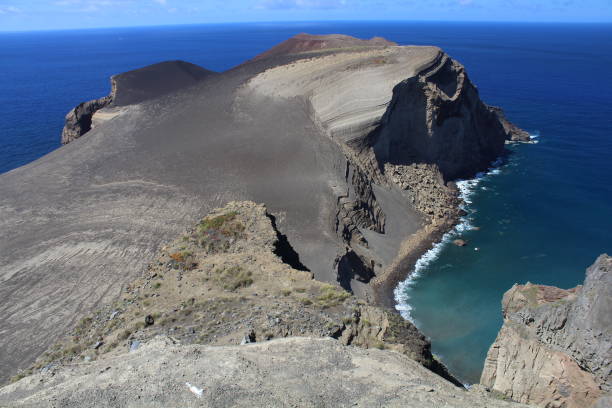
[196, 211, 245, 253]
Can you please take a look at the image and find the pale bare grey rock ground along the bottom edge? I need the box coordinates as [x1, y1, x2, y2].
[0, 336, 525, 408]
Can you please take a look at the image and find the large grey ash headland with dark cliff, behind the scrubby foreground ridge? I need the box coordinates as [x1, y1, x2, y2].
[0, 33, 524, 378]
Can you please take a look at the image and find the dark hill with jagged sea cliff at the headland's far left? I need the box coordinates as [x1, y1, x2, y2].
[61, 61, 214, 145]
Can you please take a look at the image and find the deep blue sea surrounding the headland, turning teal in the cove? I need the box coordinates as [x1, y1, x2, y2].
[0, 22, 612, 382]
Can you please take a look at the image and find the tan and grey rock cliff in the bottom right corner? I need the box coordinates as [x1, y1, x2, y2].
[481, 255, 612, 408]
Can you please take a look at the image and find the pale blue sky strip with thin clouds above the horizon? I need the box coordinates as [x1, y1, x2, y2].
[0, 0, 612, 31]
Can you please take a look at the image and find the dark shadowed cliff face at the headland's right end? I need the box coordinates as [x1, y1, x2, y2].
[373, 53, 506, 181]
